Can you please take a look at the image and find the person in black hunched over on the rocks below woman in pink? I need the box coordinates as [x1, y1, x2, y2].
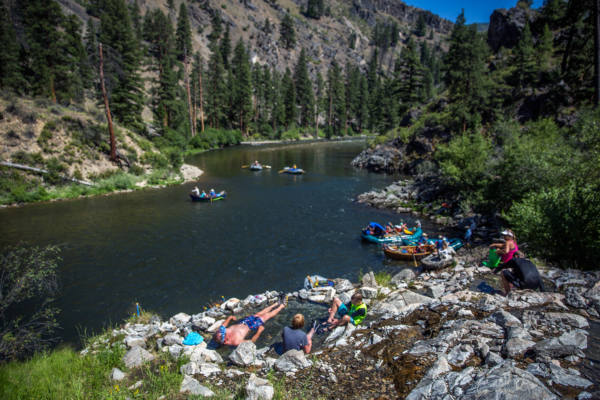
[494, 251, 544, 296]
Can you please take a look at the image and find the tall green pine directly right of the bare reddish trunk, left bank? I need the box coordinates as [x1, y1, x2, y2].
[99, 0, 145, 132]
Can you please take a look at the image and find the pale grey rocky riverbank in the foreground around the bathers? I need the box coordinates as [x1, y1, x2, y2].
[82, 250, 600, 399]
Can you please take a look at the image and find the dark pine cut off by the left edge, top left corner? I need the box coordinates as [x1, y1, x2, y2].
[0, 2, 23, 91]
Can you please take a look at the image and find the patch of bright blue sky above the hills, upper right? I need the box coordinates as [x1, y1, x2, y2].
[404, 0, 544, 24]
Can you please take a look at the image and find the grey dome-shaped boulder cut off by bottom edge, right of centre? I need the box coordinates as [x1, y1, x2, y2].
[461, 363, 558, 400]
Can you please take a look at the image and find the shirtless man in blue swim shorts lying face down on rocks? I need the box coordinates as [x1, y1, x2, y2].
[213, 294, 287, 346]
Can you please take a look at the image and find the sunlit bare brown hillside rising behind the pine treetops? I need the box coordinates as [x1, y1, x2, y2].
[59, 0, 452, 75]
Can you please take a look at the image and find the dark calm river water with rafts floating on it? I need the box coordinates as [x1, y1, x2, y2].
[0, 141, 432, 342]
